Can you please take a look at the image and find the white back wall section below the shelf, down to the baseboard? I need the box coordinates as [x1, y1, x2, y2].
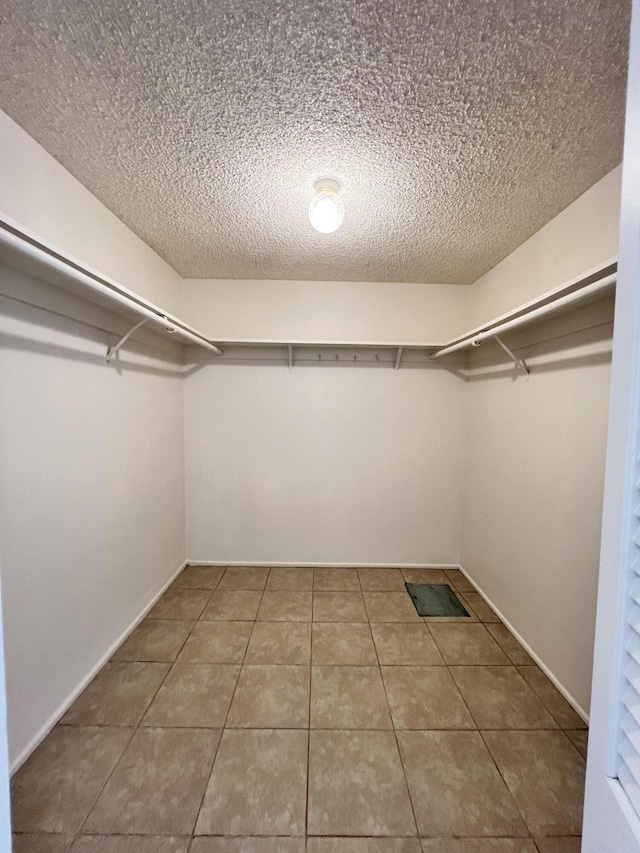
[185, 364, 464, 565]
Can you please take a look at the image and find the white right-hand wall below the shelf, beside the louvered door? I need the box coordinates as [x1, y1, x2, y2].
[462, 305, 612, 713]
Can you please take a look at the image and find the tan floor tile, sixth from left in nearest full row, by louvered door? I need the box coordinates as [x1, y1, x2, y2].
[483, 731, 584, 836]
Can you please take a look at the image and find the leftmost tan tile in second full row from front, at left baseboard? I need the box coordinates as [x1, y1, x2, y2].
[60, 661, 170, 726]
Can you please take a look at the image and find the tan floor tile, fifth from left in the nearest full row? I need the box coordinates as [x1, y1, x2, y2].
[398, 731, 527, 837]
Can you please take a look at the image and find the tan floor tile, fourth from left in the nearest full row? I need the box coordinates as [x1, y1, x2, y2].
[308, 730, 417, 836]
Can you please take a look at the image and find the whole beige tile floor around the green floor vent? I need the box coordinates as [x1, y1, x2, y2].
[12, 567, 587, 853]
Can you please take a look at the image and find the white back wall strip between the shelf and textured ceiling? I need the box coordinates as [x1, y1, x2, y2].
[184, 279, 469, 343]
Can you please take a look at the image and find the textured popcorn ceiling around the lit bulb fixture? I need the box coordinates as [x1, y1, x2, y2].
[0, 0, 630, 284]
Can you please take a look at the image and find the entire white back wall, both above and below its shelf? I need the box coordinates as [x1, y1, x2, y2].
[184, 280, 469, 565]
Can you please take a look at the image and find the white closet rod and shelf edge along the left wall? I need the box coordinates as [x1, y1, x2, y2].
[0, 219, 223, 355]
